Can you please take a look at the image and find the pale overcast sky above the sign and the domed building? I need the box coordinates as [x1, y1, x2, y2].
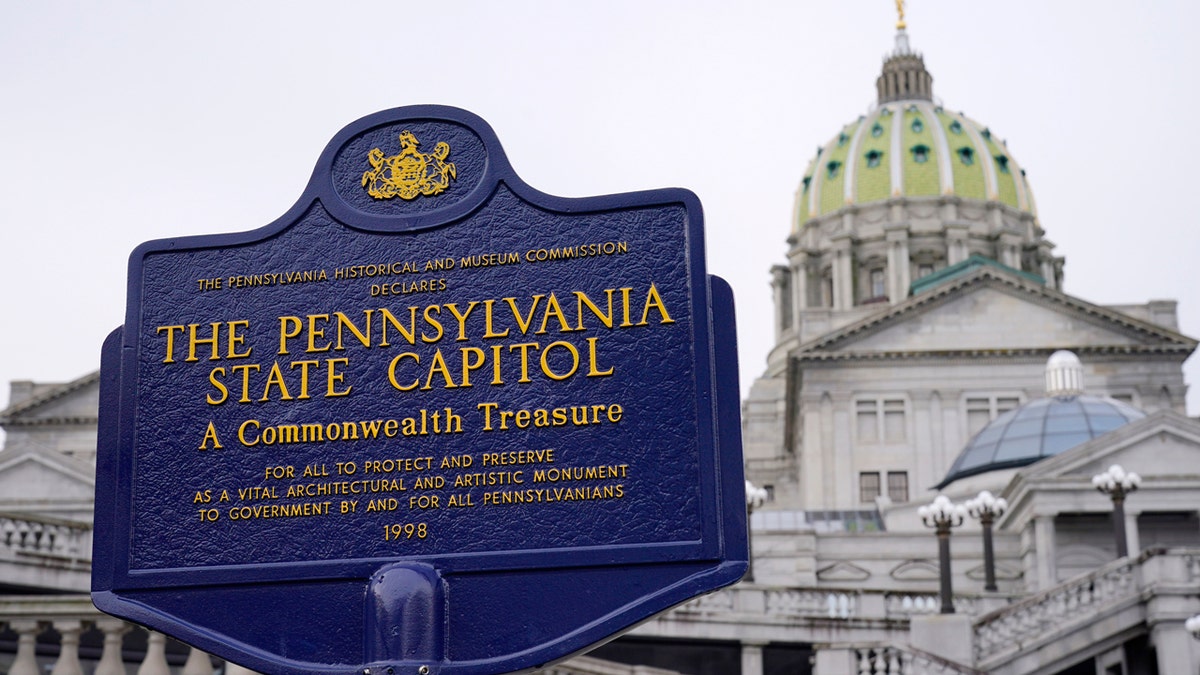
[0, 0, 1200, 414]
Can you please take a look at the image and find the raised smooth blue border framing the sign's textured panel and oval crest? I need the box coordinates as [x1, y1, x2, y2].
[92, 106, 748, 674]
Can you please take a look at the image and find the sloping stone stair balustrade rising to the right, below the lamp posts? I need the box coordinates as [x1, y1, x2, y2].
[974, 552, 1137, 663]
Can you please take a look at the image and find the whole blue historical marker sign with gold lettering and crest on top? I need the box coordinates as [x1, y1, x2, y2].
[92, 107, 748, 675]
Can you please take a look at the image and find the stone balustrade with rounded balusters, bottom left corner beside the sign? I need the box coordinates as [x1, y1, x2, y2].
[0, 596, 260, 675]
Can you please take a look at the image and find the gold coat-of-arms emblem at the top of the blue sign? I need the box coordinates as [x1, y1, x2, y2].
[362, 131, 457, 201]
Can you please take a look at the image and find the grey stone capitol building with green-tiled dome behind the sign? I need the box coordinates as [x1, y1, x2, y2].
[0, 13, 1200, 675]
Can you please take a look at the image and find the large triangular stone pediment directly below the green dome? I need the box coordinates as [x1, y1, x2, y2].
[799, 267, 1196, 358]
